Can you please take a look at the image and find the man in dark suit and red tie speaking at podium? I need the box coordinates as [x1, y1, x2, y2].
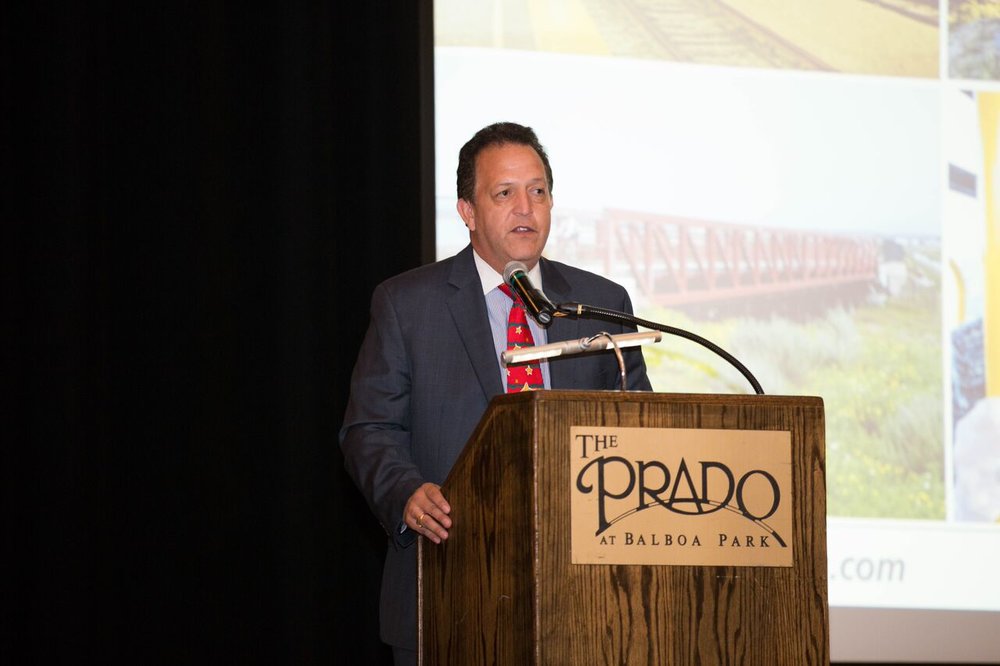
[340, 123, 650, 663]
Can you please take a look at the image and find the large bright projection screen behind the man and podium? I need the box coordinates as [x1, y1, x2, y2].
[434, 0, 1000, 662]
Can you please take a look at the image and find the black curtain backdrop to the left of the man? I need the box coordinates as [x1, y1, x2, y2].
[11, 1, 433, 664]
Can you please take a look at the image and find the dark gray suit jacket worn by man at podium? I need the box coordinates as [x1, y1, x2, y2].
[340, 246, 650, 649]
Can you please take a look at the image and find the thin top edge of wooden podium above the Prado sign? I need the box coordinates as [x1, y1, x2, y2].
[493, 389, 823, 407]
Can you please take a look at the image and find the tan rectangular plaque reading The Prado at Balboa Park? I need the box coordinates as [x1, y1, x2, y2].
[569, 426, 794, 567]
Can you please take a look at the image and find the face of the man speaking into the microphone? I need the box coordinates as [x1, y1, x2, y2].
[458, 144, 552, 273]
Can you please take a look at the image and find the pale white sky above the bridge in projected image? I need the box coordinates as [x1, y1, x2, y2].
[435, 49, 942, 253]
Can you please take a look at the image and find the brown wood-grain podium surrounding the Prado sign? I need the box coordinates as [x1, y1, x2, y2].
[418, 391, 830, 666]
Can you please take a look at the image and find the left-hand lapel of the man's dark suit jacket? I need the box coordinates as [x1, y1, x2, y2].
[447, 245, 503, 400]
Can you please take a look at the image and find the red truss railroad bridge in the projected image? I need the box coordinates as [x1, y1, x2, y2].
[597, 210, 880, 306]
